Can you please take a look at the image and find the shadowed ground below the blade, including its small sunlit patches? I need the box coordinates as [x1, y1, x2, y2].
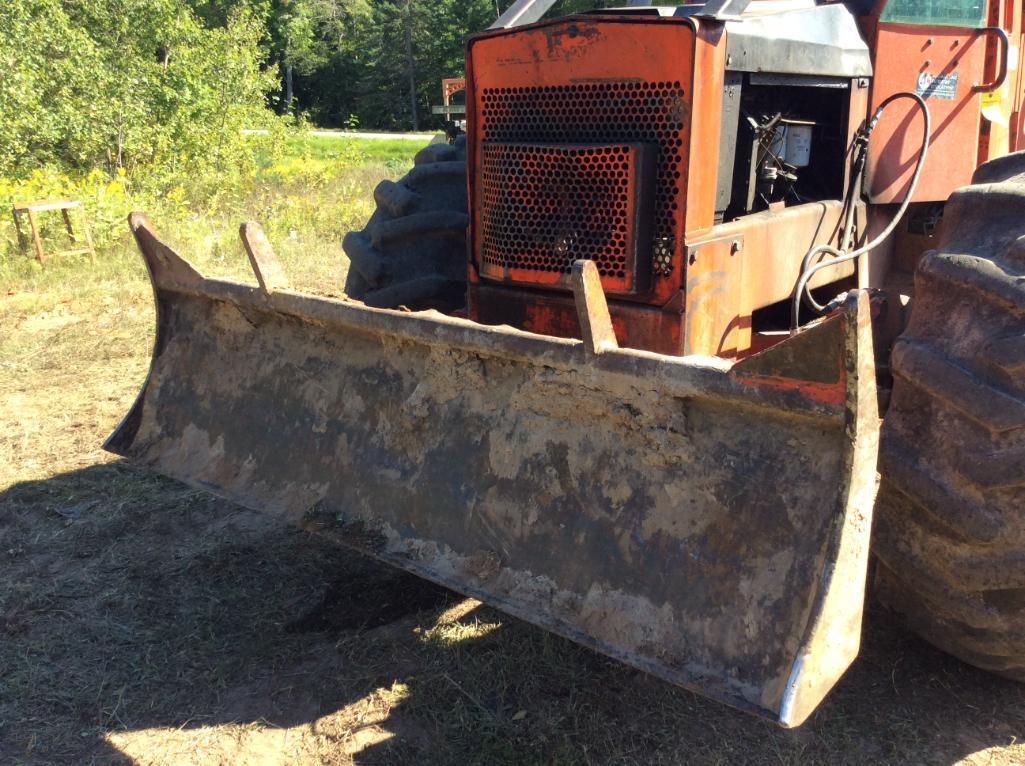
[0, 462, 1025, 764]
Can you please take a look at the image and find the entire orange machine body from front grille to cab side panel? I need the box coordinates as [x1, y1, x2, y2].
[466, 0, 1021, 358]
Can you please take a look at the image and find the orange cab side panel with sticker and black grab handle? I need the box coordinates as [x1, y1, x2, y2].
[862, 0, 1025, 203]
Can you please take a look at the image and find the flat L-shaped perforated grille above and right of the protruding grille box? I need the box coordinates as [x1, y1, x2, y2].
[479, 81, 687, 268]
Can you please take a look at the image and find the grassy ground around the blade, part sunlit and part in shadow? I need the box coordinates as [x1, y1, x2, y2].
[0, 139, 1025, 765]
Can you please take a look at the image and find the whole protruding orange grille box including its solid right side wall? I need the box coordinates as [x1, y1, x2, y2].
[476, 142, 656, 294]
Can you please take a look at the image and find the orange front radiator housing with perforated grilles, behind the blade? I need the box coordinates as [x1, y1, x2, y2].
[466, 15, 724, 354]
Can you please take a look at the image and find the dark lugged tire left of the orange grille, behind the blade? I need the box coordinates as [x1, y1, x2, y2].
[341, 136, 469, 313]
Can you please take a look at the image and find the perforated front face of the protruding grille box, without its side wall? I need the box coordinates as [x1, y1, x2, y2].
[481, 144, 634, 279]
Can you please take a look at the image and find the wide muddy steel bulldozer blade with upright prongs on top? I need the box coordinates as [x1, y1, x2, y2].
[106, 214, 878, 727]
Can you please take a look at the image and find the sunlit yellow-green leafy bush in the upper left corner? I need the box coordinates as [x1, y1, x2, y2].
[0, 0, 277, 189]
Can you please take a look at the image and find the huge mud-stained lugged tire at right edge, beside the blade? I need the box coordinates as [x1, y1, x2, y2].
[873, 153, 1025, 681]
